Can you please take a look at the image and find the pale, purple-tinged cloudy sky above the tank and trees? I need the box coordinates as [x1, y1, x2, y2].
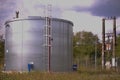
[0, 0, 120, 37]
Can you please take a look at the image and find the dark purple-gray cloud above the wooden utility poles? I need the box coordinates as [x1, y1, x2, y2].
[73, 0, 120, 17]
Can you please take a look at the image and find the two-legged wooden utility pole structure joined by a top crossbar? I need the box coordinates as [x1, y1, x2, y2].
[102, 16, 116, 69]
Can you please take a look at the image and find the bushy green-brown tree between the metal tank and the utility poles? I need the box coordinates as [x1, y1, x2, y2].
[73, 31, 101, 58]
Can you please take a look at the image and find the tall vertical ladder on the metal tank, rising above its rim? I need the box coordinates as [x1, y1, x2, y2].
[44, 4, 52, 72]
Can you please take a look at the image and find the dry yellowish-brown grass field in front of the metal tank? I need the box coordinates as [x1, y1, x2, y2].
[0, 69, 120, 80]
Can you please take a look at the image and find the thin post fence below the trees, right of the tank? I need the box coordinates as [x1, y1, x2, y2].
[74, 57, 120, 71]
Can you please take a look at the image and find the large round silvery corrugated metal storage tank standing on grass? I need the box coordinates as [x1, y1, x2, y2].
[5, 17, 73, 72]
